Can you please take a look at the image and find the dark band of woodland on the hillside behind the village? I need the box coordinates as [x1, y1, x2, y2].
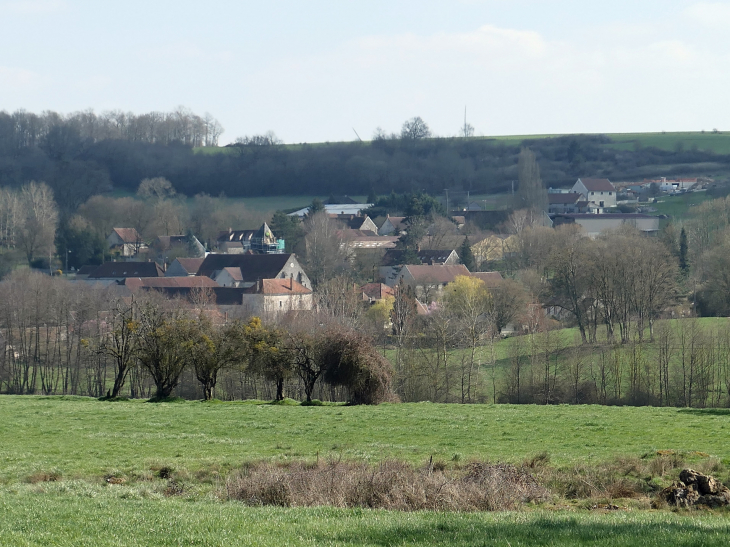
[0, 108, 730, 211]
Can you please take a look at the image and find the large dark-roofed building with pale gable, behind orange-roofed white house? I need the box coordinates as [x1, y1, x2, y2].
[197, 253, 312, 289]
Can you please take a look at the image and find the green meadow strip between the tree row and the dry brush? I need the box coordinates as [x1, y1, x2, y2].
[0, 396, 730, 484]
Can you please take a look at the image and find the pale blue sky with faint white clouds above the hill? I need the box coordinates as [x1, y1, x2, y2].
[0, 0, 730, 144]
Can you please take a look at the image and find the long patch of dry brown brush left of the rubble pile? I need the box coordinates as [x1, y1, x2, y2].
[226, 461, 548, 511]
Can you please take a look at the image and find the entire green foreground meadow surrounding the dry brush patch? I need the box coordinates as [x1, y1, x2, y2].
[0, 396, 730, 546]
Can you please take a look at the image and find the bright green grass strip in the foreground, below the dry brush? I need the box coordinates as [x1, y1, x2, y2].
[0, 492, 730, 547]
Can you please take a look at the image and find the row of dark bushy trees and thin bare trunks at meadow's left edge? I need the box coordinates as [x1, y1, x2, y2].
[0, 271, 394, 404]
